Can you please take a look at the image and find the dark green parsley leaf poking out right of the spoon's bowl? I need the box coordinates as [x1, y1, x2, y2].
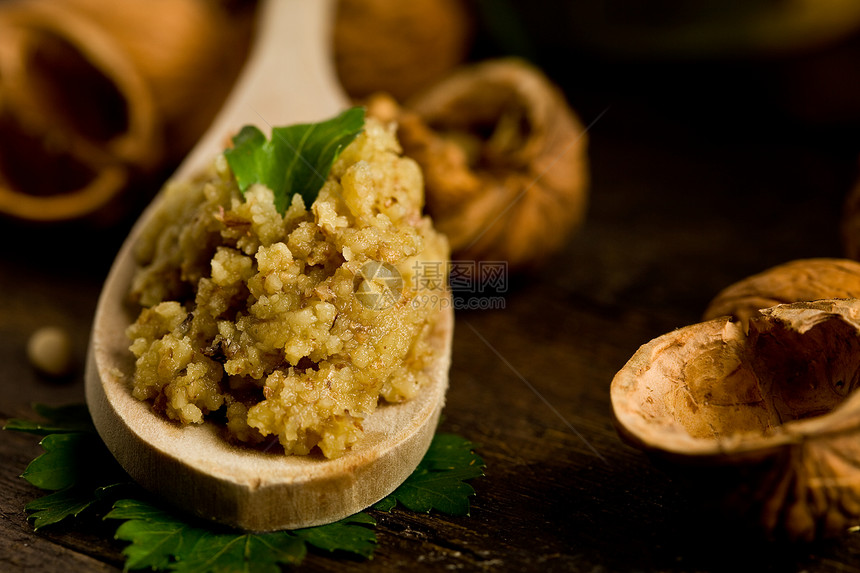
[373, 434, 485, 515]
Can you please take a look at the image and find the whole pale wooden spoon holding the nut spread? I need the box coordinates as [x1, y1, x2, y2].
[86, 0, 453, 531]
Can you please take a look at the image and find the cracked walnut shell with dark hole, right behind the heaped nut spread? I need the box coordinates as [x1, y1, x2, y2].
[369, 59, 589, 270]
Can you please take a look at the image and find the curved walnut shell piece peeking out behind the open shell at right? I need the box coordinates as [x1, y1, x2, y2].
[703, 258, 860, 321]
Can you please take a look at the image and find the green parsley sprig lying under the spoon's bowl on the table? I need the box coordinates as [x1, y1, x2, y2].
[4, 405, 484, 573]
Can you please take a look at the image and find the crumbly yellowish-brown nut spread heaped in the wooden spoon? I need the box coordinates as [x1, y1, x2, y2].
[128, 120, 448, 458]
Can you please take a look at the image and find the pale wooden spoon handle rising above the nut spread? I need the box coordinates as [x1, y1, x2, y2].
[173, 0, 349, 180]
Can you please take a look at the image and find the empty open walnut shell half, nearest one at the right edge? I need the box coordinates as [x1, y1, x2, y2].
[611, 299, 860, 540]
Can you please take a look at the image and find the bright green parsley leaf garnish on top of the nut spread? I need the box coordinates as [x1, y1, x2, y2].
[224, 107, 364, 215]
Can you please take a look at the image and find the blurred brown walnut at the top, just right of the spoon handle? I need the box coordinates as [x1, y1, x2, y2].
[334, 0, 472, 101]
